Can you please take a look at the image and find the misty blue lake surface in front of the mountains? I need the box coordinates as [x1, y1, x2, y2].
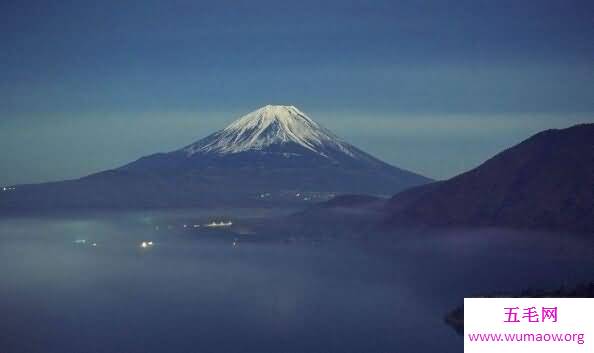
[0, 210, 594, 353]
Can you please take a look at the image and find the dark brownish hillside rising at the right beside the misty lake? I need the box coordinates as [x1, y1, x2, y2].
[386, 124, 594, 231]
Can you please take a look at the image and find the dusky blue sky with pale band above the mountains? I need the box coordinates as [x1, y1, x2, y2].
[0, 0, 594, 184]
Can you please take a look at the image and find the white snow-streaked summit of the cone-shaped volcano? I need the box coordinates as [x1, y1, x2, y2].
[184, 105, 358, 158]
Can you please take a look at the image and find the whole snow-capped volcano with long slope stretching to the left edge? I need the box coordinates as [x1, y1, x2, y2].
[0, 105, 430, 209]
